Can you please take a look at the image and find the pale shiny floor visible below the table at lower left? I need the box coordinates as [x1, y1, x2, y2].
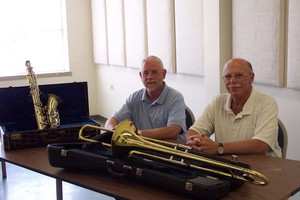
[0, 163, 114, 200]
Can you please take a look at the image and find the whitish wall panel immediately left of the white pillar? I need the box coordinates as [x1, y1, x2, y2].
[175, 0, 204, 76]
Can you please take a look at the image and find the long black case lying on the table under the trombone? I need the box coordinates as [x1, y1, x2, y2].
[47, 132, 250, 200]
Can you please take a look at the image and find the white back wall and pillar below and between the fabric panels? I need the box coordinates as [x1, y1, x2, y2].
[97, 0, 300, 160]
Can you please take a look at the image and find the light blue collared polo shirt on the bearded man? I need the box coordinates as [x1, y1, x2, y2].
[113, 82, 186, 132]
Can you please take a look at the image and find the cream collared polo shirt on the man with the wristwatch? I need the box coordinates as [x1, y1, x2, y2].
[191, 89, 281, 157]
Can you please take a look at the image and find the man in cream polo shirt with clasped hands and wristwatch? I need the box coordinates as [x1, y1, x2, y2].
[185, 58, 282, 157]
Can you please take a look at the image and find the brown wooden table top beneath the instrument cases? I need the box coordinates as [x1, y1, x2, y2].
[0, 145, 300, 200]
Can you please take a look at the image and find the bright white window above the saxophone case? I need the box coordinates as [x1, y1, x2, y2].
[0, 0, 69, 77]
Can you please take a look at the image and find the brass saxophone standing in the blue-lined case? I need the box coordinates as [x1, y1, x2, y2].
[25, 61, 62, 129]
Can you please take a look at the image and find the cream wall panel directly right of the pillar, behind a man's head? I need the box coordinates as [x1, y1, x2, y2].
[232, 0, 285, 86]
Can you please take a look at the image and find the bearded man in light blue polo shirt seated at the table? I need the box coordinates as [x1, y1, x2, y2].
[105, 56, 186, 139]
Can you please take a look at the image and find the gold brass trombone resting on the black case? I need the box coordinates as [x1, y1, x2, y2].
[79, 120, 269, 185]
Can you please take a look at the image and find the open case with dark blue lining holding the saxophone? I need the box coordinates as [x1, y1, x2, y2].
[0, 82, 103, 151]
